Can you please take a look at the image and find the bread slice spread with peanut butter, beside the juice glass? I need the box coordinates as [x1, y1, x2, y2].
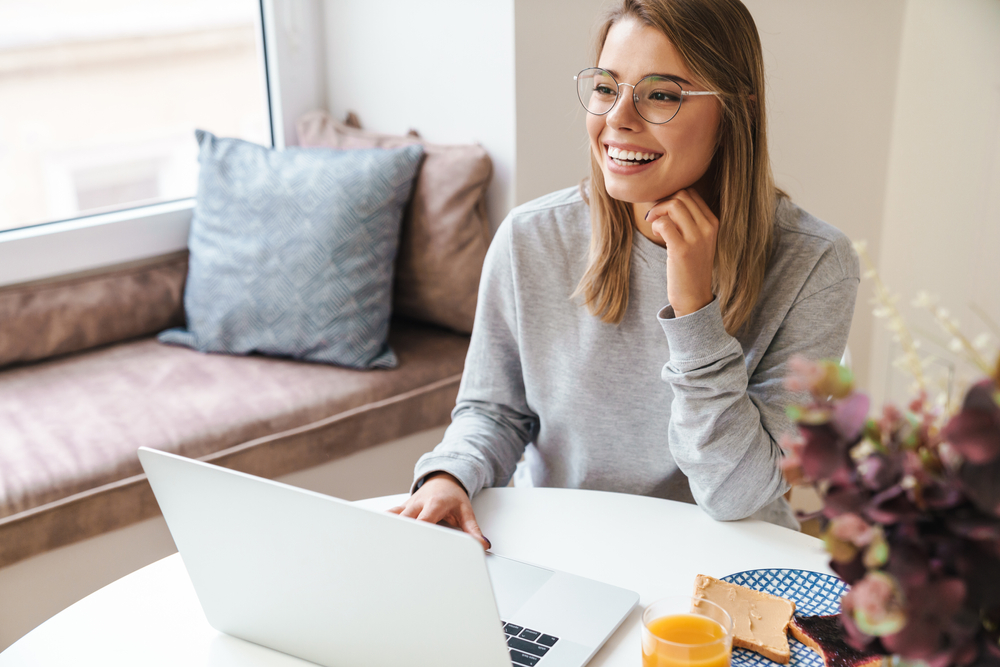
[694, 574, 795, 665]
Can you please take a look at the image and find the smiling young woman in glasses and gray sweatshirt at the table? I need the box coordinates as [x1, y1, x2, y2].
[393, 0, 859, 546]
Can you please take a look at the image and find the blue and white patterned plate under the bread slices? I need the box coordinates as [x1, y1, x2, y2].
[722, 570, 848, 667]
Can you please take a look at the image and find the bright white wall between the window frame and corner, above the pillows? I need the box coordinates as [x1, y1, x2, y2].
[324, 0, 516, 232]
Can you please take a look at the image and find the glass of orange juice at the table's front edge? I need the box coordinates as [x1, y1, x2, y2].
[642, 614, 731, 667]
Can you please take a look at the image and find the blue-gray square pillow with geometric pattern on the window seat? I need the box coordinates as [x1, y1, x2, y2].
[159, 130, 423, 368]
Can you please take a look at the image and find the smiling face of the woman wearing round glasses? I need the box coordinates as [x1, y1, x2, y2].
[587, 18, 721, 204]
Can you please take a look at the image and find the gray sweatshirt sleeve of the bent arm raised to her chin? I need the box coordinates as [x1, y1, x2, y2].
[659, 274, 859, 520]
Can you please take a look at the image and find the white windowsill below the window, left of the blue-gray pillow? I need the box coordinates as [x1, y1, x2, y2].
[0, 199, 194, 286]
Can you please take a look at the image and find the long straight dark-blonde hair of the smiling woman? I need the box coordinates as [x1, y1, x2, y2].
[574, 0, 785, 334]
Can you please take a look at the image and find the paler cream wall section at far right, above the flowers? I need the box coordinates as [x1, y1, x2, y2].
[871, 0, 1000, 404]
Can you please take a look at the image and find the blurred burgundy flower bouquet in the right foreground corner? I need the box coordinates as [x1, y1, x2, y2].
[782, 258, 1000, 667]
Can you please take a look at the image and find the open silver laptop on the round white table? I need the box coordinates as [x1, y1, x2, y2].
[139, 447, 639, 667]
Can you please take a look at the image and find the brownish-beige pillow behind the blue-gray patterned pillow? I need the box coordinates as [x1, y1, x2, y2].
[296, 111, 493, 340]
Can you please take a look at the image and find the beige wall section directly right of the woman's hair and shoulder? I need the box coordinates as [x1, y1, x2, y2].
[744, 0, 905, 394]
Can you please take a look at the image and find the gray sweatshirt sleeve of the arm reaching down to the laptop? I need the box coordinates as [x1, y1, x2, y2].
[411, 219, 539, 497]
